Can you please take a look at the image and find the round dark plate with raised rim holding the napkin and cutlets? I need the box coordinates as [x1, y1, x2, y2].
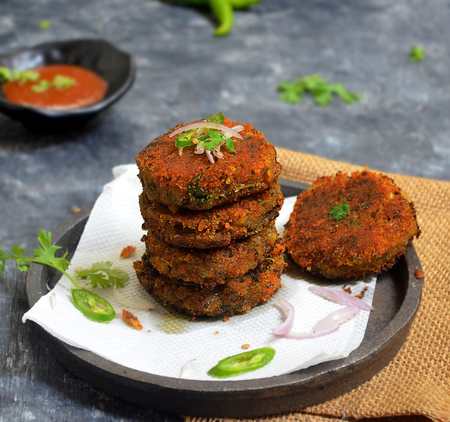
[27, 179, 422, 417]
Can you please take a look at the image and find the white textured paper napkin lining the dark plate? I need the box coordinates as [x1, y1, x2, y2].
[23, 165, 376, 380]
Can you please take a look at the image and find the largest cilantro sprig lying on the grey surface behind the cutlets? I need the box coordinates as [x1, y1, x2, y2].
[278, 74, 360, 107]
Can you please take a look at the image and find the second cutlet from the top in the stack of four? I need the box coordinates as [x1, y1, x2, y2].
[139, 184, 283, 249]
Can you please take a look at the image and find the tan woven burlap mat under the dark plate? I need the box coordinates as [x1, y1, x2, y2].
[190, 148, 450, 422]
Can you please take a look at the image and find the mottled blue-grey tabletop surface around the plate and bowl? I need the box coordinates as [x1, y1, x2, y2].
[0, 0, 450, 421]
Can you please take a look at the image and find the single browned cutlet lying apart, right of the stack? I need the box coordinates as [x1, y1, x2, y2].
[285, 171, 419, 279]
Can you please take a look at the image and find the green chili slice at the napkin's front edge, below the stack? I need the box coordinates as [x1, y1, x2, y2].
[208, 347, 275, 378]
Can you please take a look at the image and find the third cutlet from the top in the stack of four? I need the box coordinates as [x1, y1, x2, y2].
[143, 223, 278, 286]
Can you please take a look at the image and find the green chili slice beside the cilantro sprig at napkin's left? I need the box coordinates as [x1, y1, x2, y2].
[72, 289, 116, 322]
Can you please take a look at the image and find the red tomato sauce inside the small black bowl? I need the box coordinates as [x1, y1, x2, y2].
[3, 65, 108, 109]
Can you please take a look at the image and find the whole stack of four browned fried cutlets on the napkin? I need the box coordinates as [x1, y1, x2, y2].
[135, 119, 285, 317]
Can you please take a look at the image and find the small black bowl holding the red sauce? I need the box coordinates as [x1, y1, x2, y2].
[0, 39, 136, 126]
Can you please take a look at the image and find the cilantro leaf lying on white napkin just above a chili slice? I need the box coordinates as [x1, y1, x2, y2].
[75, 261, 128, 288]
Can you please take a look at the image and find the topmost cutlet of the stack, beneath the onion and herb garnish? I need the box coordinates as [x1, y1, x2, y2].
[136, 119, 281, 211]
